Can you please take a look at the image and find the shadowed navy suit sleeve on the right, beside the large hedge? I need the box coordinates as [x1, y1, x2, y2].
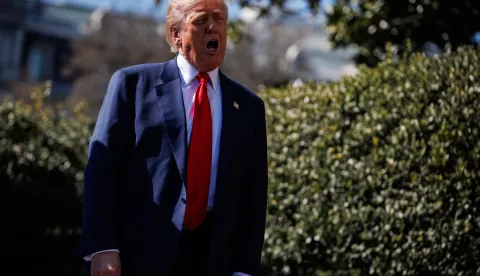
[234, 99, 268, 276]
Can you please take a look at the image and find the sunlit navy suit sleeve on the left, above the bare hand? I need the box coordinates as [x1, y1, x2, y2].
[78, 70, 133, 257]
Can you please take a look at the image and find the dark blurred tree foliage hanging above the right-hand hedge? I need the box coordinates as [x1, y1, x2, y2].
[327, 0, 480, 66]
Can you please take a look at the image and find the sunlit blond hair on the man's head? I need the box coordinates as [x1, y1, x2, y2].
[165, 0, 228, 53]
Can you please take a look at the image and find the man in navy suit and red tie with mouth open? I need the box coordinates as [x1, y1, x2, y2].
[79, 0, 267, 276]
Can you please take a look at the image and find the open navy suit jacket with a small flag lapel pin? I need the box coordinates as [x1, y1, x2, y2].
[78, 59, 268, 276]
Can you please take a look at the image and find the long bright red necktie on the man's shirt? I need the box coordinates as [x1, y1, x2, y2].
[184, 73, 212, 230]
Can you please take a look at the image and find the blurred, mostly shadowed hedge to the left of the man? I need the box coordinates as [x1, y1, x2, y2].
[0, 87, 91, 276]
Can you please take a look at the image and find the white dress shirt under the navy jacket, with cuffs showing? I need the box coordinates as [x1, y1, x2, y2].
[85, 54, 249, 276]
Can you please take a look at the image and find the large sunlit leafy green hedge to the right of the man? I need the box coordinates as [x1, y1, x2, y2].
[262, 48, 480, 275]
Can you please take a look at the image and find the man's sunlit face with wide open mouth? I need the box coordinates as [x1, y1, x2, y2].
[171, 0, 227, 72]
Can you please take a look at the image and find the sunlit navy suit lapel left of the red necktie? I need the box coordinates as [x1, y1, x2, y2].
[155, 58, 187, 185]
